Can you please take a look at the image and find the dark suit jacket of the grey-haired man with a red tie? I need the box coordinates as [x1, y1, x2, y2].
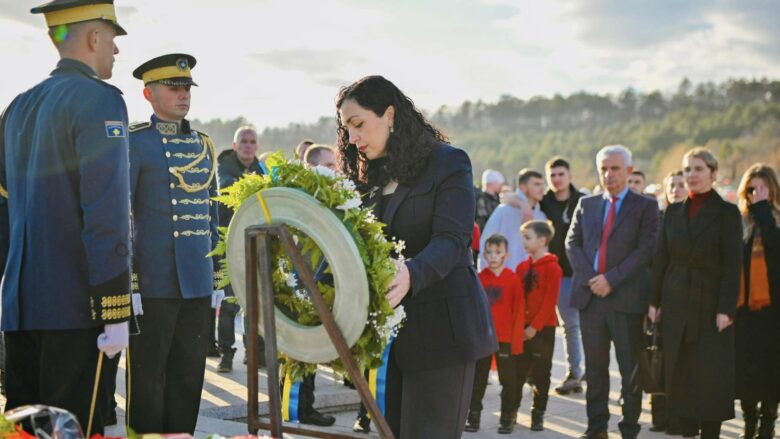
[566, 191, 658, 313]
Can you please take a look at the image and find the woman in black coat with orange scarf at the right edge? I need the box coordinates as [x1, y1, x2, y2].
[734, 163, 780, 439]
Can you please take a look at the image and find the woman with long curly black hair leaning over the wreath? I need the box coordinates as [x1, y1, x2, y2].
[336, 76, 498, 439]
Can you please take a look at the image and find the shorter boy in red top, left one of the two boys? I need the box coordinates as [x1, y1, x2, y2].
[465, 234, 525, 432]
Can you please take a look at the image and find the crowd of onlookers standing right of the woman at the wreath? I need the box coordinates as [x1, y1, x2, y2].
[466, 145, 780, 438]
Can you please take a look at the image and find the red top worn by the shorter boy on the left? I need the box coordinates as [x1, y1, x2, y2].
[479, 268, 525, 354]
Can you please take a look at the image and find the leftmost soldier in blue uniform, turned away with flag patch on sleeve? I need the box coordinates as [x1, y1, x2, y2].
[0, 0, 131, 434]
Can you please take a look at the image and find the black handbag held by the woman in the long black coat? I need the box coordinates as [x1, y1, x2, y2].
[631, 320, 666, 395]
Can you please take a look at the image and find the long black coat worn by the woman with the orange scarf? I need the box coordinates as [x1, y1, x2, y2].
[735, 201, 780, 401]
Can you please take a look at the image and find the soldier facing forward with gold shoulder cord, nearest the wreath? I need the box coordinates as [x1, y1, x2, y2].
[127, 54, 224, 434]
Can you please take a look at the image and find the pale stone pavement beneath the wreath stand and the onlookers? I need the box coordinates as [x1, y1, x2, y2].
[0, 322, 768, 439]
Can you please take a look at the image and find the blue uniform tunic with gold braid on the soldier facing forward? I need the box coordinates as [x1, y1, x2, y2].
[130, 115, 219, 299]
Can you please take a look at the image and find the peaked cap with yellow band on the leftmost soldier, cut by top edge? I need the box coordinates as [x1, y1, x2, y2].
[30, 0, 127, 35]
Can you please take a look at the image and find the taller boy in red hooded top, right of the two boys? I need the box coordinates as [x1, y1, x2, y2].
[515, 221, 563, 431]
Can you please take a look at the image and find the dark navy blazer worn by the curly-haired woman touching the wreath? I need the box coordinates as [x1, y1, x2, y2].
[365, 144, 498, 370]
